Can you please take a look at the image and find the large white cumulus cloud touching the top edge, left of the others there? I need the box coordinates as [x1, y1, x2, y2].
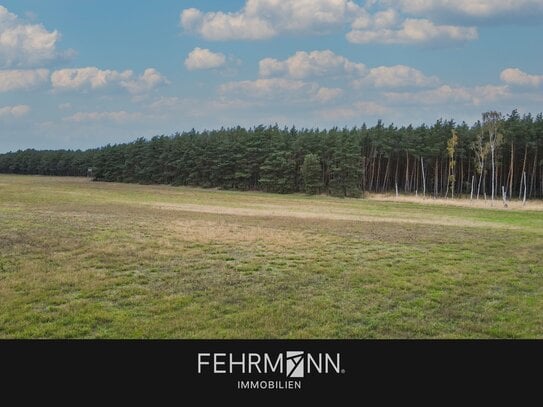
[181, 0, 361, 41]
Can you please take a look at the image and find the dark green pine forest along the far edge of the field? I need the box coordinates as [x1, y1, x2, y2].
[0, 110, 543, 199]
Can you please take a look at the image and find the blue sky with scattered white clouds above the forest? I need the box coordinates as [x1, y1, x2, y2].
[0, 0, 543, 152]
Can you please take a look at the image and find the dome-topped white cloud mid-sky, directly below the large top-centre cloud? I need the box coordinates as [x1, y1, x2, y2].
[260, 50, 366, 79]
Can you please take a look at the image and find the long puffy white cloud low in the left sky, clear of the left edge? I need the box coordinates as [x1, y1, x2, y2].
[51, 67, 168, 94]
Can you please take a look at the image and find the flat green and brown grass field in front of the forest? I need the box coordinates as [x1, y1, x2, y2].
[0, 176, 543, 338]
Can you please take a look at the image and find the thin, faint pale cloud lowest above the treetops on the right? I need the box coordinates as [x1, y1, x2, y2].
[384, 85, 511, 106]
